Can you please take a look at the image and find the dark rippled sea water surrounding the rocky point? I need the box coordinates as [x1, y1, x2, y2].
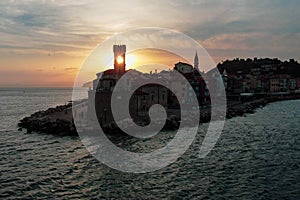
[0, 89, 300, 199]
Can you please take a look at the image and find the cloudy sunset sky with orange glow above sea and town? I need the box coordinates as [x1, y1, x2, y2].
[0, 0, 300, 87]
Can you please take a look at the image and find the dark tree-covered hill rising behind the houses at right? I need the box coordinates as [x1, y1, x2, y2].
[217, 58, 300, 77]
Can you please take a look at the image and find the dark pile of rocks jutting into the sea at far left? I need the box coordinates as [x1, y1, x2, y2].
[18, 104, 77, 136]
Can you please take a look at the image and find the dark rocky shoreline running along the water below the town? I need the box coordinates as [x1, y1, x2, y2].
[18, 94, 300, 136]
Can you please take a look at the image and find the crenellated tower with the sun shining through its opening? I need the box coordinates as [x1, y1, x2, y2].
[113, 44, 126, 74]
